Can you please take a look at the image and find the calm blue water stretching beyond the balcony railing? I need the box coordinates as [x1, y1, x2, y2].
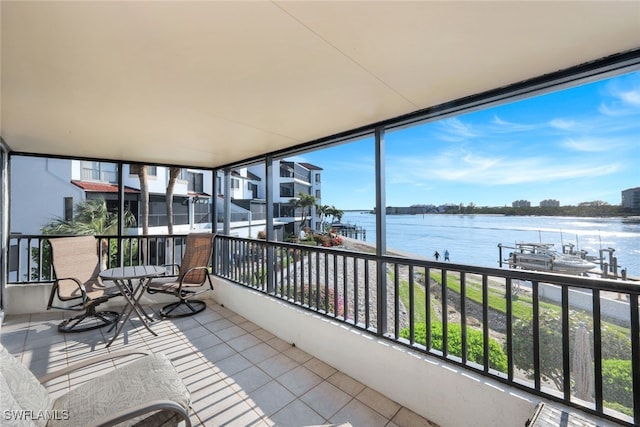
[342, 212, 640, 276]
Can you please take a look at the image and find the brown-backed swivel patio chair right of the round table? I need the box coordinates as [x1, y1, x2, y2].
[147, 233, 215, 318]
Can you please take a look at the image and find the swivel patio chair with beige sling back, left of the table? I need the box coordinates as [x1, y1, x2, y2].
[47, 236, 120, 332]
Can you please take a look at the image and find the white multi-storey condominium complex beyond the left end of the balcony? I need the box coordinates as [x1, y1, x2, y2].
[11, 156, 322, 238]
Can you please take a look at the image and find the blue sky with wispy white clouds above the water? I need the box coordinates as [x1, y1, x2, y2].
[289, 72, 640, 210]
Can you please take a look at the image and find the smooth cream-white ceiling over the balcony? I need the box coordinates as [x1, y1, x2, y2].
[0, 1, 640, 167]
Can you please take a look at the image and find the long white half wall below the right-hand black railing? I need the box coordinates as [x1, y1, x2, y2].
[212, 278, 540, 427]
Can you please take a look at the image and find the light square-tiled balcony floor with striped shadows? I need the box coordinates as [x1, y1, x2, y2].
[0, 302, 435, 427]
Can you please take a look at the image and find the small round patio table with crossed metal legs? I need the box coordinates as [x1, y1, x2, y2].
[100, 265, 167, 347]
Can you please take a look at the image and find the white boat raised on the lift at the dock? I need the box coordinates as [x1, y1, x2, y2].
[505, 243, 598, 275]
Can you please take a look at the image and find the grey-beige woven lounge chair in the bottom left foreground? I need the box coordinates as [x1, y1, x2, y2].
[0, 345, 191, 427]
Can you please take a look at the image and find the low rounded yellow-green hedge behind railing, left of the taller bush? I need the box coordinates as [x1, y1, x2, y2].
[400, 322, 507, 372]
